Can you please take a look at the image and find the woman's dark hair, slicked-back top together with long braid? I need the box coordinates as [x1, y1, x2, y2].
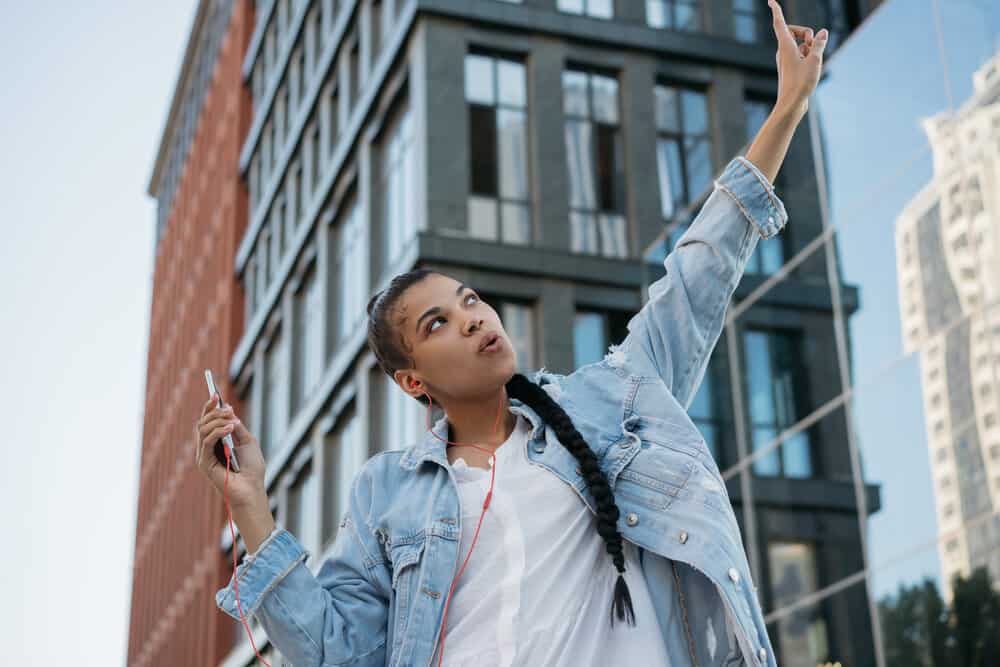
[367, 268, 635, 627]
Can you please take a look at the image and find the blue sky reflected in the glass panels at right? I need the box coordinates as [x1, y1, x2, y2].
[812, 0, 1000, 596]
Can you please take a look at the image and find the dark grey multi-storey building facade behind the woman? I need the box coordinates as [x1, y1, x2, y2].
[222, 0, 878, 666]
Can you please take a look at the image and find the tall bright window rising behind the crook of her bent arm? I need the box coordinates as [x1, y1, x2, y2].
[321, 404, 368, 547]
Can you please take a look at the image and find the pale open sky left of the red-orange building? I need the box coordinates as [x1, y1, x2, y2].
[0, 0, 196, 666]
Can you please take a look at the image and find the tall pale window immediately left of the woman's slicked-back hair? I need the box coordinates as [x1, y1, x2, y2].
[336, 190, 368, 340]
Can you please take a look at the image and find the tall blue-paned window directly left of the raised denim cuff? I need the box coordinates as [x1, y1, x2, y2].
[653, 84, 713, 232]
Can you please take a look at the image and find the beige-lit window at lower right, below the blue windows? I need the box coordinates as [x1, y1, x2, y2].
[767, 542, 830, 665]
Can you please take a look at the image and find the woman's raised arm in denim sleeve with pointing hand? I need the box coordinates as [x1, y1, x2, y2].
[620, 0, 828, 409]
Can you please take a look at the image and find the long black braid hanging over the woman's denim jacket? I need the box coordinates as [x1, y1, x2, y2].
[507, 373, 635, 627]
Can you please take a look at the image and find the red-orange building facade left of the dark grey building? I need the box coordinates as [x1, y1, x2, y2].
[128, 0, 253, 667]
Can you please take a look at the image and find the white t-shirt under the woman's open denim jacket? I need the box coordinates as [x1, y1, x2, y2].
[431, 415, 670, 667]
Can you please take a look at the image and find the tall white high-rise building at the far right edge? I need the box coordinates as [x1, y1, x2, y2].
[896, 52, 1000, 599]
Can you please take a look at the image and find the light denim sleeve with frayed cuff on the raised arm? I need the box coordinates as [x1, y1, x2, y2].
[618, 156, 788, 410]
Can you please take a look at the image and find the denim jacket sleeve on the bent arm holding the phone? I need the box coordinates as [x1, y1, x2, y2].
[215, 464, 390, 667]
